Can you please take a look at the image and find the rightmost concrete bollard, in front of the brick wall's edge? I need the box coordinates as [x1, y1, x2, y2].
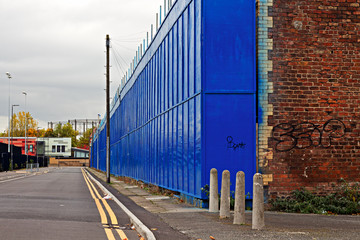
[252, 173, 265, 230]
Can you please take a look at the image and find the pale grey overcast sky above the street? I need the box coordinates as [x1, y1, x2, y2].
[0, 0, 164, 132]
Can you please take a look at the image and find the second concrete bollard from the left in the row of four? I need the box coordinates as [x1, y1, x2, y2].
[220, 170, 230, 218]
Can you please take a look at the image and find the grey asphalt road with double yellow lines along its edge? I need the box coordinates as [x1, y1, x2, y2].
[0, 168, 139, 240]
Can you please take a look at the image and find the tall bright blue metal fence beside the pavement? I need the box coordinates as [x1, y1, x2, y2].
[91, 0, 256, 198]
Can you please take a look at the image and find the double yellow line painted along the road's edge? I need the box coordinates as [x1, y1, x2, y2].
[81, 168, 127, 240]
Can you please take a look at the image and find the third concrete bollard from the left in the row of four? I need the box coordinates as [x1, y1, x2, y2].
[233, 171, 245, 224]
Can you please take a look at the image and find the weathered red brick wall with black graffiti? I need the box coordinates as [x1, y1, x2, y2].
[263, 0, 360, 197]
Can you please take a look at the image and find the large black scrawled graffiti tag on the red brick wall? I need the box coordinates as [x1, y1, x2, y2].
[271, 119, 346, 152]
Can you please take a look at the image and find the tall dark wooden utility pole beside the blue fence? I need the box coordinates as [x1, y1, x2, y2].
[106, 35, 110, 183]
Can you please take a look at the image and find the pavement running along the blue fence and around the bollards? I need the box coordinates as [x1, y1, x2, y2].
[89, 169, 360, 240]
